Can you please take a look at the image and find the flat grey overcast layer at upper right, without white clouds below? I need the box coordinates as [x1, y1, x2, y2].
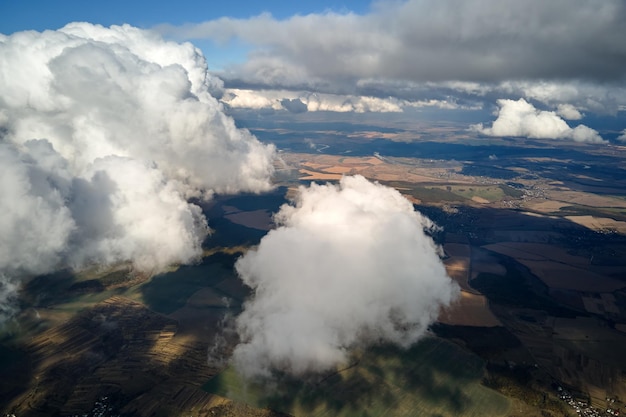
[160, 0, 626, 83]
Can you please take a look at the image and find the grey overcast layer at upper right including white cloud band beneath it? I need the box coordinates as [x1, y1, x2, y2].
[157, 0, 626, 117]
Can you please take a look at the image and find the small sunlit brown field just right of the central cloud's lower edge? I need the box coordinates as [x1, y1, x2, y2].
[439, 291, 502, 327]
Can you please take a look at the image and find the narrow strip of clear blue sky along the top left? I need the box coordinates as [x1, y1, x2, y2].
[0, 0, 369, 34]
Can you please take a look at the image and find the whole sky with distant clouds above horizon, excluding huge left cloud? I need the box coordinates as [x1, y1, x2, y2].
[0, 0, 626, 135]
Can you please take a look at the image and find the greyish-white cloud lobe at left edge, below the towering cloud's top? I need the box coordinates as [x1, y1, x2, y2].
[0, 141, 76, 275]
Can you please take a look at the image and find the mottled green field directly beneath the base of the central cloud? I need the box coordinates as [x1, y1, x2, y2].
[204, 337, 509, 417]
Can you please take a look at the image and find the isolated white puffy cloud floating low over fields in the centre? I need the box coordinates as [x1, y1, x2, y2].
[234, 176, 459, 377]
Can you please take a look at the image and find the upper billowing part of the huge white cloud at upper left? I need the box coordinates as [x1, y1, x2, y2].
[0, 24, 274, 192]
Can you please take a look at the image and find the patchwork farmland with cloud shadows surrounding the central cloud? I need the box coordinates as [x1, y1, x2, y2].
[0, 140, 626, 417]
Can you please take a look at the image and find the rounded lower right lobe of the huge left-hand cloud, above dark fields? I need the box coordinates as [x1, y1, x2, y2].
[68, 156, 207, 272]
